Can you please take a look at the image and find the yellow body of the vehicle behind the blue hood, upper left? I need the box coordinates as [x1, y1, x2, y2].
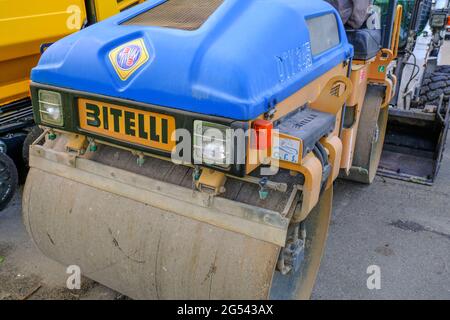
[0, 0, 144, 106]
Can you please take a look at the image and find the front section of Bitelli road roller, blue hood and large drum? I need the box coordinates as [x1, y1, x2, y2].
[23, 0, 400, 299]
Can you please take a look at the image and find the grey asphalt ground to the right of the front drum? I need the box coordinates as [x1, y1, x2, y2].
[313, 144, 450, 300]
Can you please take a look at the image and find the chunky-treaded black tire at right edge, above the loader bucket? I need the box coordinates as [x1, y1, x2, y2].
[420, 66, 450, 106]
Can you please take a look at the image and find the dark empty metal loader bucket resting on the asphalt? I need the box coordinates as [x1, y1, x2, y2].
[378, 102, 450, 185]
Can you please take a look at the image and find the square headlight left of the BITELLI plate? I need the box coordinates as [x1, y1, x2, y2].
[39, 90, 64, 126]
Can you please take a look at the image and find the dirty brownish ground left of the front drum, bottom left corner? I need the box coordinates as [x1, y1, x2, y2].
[0, 193, 123, 300]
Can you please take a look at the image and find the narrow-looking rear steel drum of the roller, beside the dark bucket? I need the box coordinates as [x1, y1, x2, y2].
[343, 85, 389, 184]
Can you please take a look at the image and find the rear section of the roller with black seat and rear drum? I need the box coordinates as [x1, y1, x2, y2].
[327, 0, 403, 184]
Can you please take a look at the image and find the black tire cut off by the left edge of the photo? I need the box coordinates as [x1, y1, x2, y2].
[0, 152, 19, 211]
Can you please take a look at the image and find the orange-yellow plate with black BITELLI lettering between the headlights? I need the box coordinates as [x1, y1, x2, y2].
[78, 99, 175, 151]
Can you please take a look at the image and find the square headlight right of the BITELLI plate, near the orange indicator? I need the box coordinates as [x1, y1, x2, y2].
[194, 120, 232, 168]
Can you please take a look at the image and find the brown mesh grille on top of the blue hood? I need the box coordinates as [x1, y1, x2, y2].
[123, 0, 223, 30]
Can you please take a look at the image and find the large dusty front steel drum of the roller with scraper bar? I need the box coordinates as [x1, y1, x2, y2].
[23, 142, 333, 299]
